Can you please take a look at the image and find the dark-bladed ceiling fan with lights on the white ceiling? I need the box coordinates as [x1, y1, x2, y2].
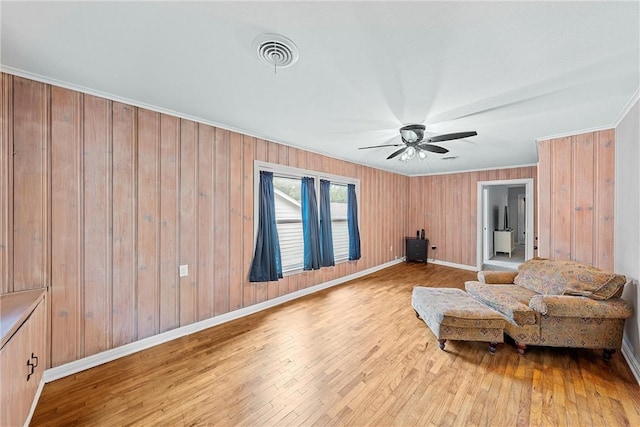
[360, 124, 478, 161]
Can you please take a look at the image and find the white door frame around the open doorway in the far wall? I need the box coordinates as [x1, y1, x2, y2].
[476, 178, 534, 271]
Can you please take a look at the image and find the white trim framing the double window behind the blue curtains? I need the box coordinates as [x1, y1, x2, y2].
[253, 160, 362, 276]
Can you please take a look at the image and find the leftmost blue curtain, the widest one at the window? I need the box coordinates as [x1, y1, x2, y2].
[249, 171, 282, 282]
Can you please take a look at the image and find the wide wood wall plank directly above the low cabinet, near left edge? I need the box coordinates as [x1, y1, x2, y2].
[13, 77, 50, 291]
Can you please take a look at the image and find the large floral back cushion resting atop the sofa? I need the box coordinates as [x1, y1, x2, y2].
[513, 258, 626, 300]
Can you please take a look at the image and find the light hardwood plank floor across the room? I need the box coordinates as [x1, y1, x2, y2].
[32, 264, 640, 426]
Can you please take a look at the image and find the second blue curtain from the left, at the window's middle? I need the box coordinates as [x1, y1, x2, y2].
[302, 177, 320, 270]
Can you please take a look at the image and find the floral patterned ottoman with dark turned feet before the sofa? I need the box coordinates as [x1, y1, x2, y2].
[411, 286, 506, 353]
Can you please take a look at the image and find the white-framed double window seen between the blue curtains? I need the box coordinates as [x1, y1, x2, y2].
[254, 161, 359, 275]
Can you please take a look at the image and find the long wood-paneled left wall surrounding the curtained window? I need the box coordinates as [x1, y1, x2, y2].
[0, 74, 410, 366]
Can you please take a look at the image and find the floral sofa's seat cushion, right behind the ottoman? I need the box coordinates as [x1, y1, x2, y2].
[465, 281, 536, 325]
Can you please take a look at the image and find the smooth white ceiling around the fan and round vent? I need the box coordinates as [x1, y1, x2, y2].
[0, 1, 640, 175]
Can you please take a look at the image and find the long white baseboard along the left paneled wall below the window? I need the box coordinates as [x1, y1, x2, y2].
[43, 258, 404, 382]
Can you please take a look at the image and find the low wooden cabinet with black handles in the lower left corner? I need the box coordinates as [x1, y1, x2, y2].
[0, 289, 47, 426]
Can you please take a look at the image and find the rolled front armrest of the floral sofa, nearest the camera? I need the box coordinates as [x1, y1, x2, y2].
[529, 295, 633, 319]
